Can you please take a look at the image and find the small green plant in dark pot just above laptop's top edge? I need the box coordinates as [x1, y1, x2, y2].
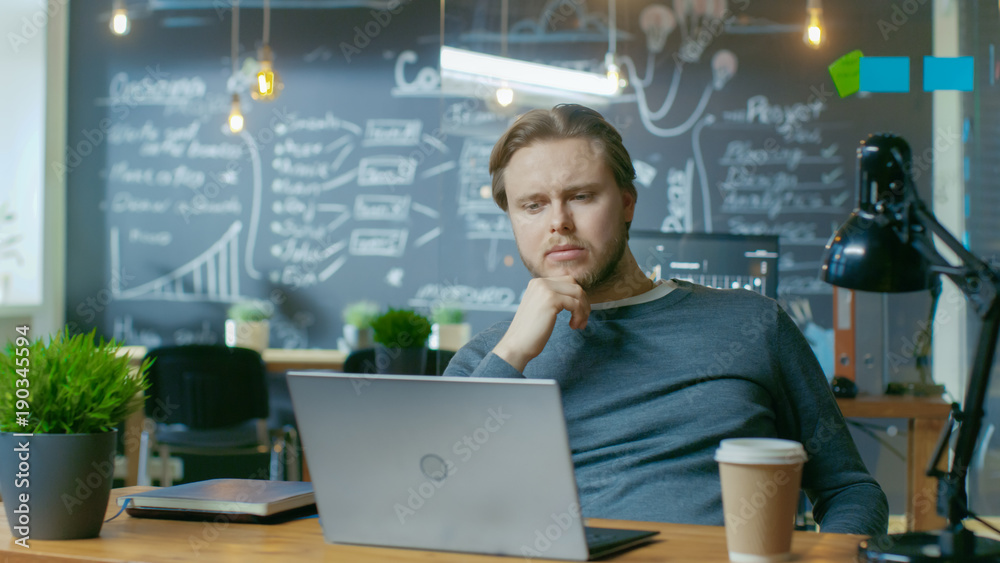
[372, 307, 431, 375]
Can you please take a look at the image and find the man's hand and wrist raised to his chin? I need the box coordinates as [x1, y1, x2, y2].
[493, 276, 590, 373]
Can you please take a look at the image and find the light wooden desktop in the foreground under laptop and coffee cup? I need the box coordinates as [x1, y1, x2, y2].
[0, 487, 861, 563]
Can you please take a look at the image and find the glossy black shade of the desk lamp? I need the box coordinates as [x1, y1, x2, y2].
[820, 209, 933, 293]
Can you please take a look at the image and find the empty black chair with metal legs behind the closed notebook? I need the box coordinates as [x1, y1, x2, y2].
[139, 345, 299, 486]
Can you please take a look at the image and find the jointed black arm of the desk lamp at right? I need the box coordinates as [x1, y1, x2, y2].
[899, 198, 1000, 528]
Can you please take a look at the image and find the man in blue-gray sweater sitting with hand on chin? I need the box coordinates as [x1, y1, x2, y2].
[445, 105, 888, 535]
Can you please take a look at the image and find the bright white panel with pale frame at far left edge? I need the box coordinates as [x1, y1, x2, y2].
[0, 0, 69, 342]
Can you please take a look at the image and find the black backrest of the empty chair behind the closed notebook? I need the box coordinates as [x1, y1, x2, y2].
[146, 344, 268, 429]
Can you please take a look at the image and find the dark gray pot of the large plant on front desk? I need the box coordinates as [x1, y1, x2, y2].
[0, 430, 118, 541]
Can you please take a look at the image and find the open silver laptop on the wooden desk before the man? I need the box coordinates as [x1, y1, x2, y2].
[288, 371, 655, 561]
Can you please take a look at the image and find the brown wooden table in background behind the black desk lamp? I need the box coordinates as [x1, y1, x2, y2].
[837, 395, 951, 531]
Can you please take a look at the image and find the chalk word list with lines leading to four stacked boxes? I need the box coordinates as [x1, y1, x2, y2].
[258, 112, 455, 287]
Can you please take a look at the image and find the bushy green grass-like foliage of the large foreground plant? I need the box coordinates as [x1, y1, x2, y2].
[0, 329, 151, 434]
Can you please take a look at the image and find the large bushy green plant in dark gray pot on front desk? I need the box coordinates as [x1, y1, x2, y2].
[0, 327, 150, 544]
